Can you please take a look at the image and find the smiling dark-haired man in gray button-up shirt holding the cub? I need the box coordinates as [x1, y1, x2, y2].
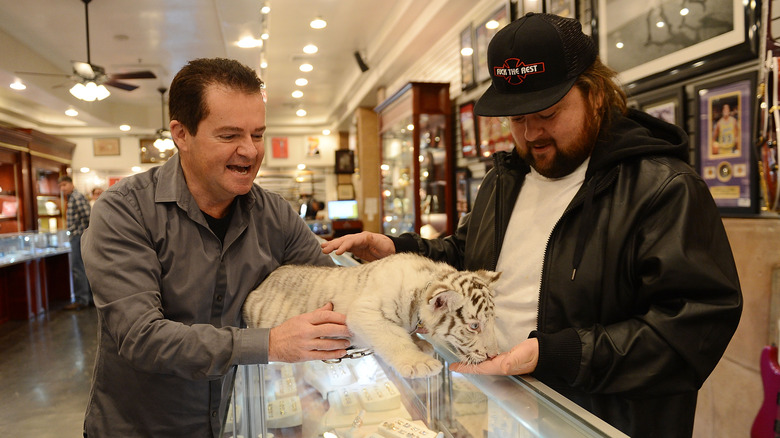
[83, 58, 349, 438]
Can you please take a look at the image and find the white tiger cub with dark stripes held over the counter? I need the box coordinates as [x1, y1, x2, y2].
[243, 253, 500, 378]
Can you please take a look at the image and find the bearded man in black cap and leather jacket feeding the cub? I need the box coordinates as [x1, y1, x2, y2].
[322, 14, 742, 438]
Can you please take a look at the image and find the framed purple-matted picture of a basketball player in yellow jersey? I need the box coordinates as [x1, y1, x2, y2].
[695, 72, 759, 216]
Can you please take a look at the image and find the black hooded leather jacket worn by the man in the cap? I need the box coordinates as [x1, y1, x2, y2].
[394, 110, 742, 438]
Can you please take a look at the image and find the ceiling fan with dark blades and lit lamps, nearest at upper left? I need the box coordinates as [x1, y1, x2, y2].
[17, 0, 157, 101]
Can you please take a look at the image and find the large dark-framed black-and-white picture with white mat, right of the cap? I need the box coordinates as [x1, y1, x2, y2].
[593, 0, 760, 92]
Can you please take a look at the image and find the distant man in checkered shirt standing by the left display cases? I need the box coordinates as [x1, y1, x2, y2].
[58, 175, 93, 310]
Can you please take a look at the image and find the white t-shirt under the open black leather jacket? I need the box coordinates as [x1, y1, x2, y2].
[495, 159, 590, 351]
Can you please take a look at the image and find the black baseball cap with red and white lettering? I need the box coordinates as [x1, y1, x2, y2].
[474, 12, 597, 117]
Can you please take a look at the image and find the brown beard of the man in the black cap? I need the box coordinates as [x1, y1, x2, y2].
[517, 117, 601, 179]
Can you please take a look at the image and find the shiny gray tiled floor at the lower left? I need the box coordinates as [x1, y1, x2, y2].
[0, 308, 97, 438]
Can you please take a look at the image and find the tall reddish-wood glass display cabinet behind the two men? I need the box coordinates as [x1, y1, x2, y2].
[375, 82, 455, 238]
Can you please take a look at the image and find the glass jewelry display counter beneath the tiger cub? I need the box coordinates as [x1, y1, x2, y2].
[222, 338, 626, 438]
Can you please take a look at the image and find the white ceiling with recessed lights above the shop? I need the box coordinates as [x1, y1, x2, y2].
[0, 0, 478, 136]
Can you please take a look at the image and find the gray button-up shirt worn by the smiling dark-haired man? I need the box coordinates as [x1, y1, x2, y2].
[82, 154, 333, 437]
